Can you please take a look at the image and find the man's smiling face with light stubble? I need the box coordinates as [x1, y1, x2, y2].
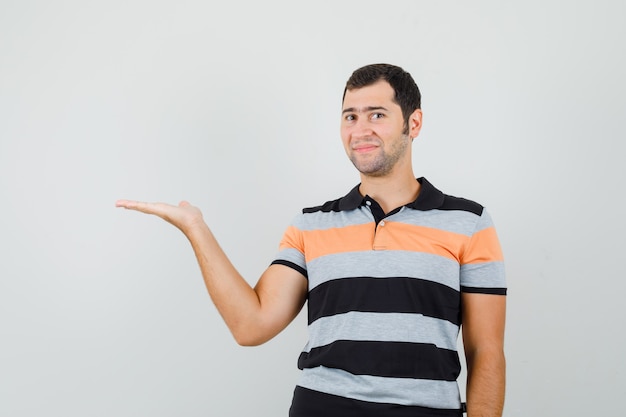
[341, 81, 411, 177]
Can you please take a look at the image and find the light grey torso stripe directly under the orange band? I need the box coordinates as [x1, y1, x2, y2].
[307, 251, 460, 291]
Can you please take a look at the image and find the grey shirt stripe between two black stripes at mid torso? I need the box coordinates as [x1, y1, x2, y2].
[304, 312, 459, 353]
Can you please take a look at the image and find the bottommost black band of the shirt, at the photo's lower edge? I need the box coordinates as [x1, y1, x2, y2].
[289, 386, 462, 417]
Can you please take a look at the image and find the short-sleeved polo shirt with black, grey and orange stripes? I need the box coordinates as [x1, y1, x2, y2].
[273, 178, 506, 417]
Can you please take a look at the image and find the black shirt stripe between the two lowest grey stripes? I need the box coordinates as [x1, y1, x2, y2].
[298, 340, 461, 381]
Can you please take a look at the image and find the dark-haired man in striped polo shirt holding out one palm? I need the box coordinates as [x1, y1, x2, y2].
[117, 64, 506, 417]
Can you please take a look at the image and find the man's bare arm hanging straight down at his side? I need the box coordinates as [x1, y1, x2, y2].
[462, 293, 506, 417]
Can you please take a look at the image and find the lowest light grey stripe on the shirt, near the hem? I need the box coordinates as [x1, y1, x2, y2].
[298, 367, 461, 409]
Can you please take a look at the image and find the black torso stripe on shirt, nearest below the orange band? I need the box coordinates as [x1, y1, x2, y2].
[309, 277, 461, 325]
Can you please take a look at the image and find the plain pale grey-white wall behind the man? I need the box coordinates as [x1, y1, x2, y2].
[0, 0, 626, 417]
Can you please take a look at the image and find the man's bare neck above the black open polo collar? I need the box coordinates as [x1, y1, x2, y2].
[359, 170, 420, 213]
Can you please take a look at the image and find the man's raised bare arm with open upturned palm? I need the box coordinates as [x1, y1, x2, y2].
[116, 200, 307, 346]
